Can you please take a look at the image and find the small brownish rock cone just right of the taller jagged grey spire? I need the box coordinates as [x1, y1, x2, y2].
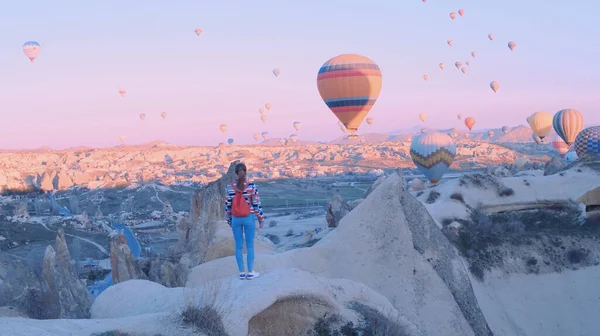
[110, 232, 146, 284]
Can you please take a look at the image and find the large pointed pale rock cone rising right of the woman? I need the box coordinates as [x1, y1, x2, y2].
[187, 174, 491, 336]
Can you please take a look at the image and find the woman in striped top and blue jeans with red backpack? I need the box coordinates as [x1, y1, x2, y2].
[225, 163, 264, 280]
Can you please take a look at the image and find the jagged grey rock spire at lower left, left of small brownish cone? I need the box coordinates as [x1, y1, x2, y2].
[42, 230, 93, 318]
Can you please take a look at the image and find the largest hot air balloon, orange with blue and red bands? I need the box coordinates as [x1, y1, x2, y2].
[317, 54, 381, 133]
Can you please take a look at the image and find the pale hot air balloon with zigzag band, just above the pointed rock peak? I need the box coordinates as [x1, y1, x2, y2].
[410, 132, 456, 184]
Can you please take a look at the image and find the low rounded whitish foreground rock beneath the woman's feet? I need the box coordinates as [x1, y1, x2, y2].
[92, 268, 426, 336]
